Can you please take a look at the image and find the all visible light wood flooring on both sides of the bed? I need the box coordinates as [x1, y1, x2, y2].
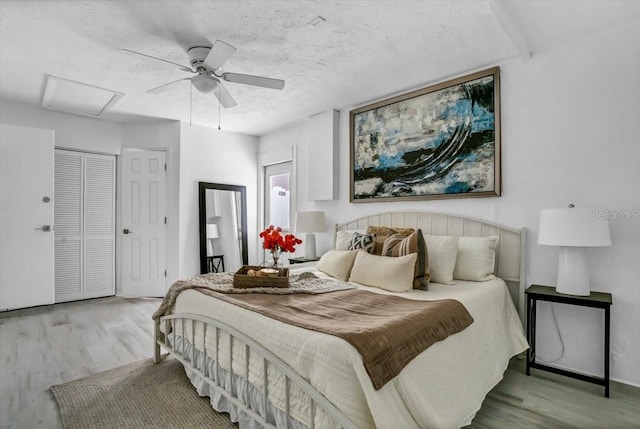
[0, 297, 640, 429]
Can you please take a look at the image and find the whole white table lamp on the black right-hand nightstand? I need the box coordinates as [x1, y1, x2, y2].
[538, 204, 611, 296]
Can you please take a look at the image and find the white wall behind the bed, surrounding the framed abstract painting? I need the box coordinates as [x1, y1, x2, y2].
[259, 22, 640, 385]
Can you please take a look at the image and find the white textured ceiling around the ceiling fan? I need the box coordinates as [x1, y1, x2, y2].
[0, 0, 640, 135]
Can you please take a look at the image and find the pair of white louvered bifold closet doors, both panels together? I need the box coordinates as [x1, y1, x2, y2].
[54, 149, 115, 302]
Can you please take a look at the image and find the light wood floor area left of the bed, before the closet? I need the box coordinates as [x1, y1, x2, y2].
[0, 297, 160, 429]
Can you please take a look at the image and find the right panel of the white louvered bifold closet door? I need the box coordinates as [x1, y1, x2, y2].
[83, 153, 115, 298]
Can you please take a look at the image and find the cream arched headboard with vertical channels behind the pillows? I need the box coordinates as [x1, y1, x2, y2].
[336, 212, 526, 318]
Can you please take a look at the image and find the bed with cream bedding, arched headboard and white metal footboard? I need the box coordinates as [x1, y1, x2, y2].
[155, 212, 528, 428]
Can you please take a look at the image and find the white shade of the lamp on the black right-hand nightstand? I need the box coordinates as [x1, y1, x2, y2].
[538, 207, 611, 247]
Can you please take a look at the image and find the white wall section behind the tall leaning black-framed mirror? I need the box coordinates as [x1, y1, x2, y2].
[179, 123, 258, 278]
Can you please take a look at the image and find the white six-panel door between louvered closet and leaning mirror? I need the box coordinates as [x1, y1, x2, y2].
[120, 149, 167, 296]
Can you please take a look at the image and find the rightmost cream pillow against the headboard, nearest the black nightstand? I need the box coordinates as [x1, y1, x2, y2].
[453, 235, 498, 282]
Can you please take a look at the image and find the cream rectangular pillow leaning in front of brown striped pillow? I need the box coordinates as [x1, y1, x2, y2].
[349, 250, 418, 292]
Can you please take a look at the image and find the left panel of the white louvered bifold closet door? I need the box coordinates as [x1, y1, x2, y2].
[53, 149, 84, 302]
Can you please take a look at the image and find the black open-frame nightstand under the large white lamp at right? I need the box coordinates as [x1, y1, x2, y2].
[524, 285, 613, 398]
